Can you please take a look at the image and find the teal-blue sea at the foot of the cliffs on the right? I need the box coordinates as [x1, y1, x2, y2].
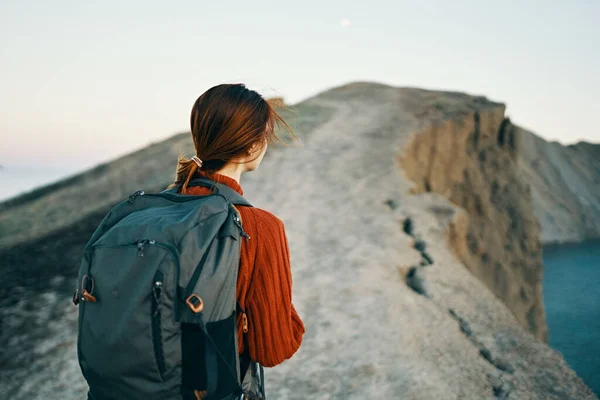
[543, 240, 600, 396]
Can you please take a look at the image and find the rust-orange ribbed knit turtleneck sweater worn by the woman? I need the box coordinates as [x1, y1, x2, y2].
[188, 173, 304, 367]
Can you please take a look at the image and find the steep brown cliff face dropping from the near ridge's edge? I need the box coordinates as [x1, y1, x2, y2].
[401, 106, 547, 341]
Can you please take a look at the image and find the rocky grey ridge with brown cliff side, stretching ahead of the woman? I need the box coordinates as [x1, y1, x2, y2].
[0, 83, 596, 400]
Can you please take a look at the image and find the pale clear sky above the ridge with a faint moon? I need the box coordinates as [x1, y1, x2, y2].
[0, 0, 600, 167]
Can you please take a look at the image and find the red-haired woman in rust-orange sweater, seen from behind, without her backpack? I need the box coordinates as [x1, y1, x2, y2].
[172, 84, 304, 382]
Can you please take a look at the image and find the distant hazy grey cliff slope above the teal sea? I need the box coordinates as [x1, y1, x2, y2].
[516, 128, 600, 243]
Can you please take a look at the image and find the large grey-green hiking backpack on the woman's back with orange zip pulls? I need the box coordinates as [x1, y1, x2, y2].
[73, 178, 264, 400]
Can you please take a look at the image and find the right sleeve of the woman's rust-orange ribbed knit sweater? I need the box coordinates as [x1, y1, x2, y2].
[246, 214, 304, 367]
